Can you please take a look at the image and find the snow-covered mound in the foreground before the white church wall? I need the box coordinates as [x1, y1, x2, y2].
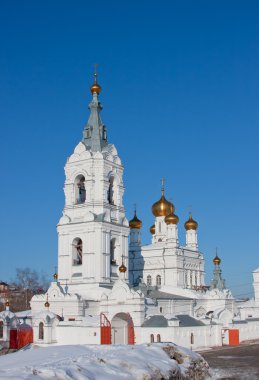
[0, 343, 208, 380]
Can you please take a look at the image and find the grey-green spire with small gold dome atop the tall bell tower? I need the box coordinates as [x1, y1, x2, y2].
[82, 65, 107, 152]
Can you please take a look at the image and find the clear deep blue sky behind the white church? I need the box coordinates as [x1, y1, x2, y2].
[0, 0, 259, 295]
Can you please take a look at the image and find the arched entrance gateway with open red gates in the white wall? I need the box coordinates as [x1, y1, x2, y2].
[111, 313, 135, 344]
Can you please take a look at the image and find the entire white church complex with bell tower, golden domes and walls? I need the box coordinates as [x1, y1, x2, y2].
[0, 74, 259, 349]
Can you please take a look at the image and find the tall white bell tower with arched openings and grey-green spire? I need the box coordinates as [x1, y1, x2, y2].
[57, 72, 129, 294]
